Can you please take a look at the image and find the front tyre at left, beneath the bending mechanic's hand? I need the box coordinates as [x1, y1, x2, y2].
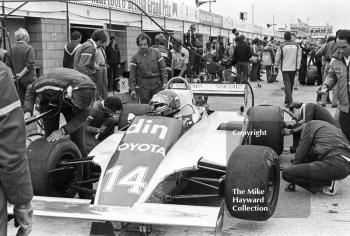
[27, 138, 83, 198]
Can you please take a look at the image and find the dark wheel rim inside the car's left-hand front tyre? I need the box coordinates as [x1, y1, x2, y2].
[49, 153, 81, 196]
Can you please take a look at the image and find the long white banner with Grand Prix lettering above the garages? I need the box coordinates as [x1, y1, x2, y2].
[82, 0, 199, 22]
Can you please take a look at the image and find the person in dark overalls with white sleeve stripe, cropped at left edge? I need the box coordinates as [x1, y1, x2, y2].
[0, 62, 33, 236]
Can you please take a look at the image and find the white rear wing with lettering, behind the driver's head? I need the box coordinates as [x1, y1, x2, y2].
[171, 83, 248, 97]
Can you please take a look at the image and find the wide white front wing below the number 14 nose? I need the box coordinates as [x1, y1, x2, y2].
[7, 196, 224, 231]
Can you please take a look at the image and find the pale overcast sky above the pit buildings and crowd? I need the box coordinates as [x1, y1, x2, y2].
[189, 0, 350, 32]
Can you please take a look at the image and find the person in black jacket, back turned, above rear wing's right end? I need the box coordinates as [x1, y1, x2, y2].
[233, 35, 252, 79]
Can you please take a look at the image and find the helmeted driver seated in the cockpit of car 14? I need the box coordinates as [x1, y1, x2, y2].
[148, 89, 199, 128]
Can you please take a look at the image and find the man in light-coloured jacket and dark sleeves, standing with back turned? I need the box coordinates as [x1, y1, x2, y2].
[275, 32, 301, 107]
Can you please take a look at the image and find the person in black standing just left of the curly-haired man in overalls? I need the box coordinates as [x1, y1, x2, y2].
[106, 35, 120, 90]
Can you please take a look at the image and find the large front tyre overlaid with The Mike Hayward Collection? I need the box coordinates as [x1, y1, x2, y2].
[225, 145, 280, 221]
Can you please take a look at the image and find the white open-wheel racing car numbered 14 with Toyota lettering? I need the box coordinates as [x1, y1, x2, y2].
[9, 77, 284, 232]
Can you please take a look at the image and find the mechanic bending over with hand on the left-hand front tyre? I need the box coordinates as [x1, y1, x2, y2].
[24, 68, 96, 157]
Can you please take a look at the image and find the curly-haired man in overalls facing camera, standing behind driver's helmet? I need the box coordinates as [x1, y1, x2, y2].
[130, 33, 168, 103]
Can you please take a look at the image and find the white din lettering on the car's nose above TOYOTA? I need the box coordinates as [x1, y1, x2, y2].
[126, 119, 168, 140]
